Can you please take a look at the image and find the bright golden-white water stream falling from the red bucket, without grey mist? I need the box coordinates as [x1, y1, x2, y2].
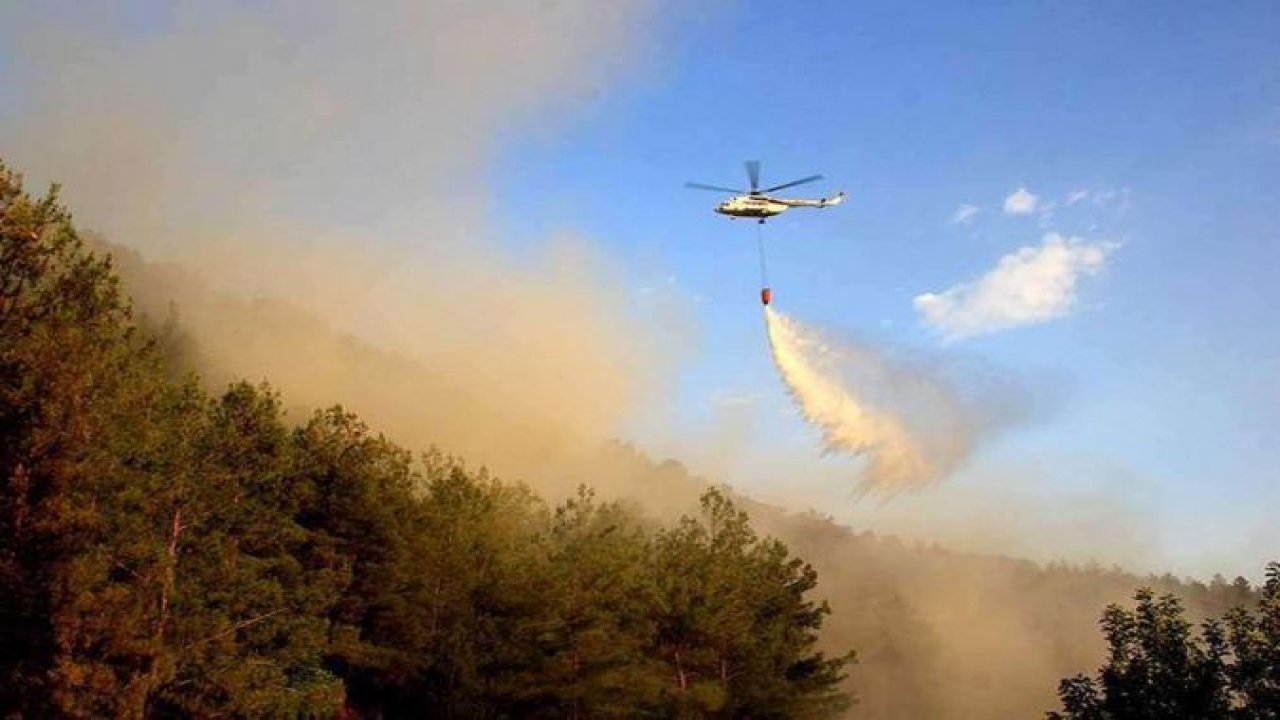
[764, 306, 940, 493]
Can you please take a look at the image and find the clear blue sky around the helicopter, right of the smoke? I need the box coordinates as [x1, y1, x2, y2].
[494, 1, 1280, 571]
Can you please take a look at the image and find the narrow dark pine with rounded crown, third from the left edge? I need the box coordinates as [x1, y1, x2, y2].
[294, 407, 430, 712]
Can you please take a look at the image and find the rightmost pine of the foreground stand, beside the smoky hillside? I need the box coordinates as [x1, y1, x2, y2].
[654, 489, 851, 717]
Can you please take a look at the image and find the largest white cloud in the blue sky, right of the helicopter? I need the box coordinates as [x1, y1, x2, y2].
[914, 232, 1114, 340]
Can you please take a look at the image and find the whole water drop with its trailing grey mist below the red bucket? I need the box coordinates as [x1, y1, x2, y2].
[764, 306, 979, 495]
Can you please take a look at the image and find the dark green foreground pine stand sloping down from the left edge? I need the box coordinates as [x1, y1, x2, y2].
[0, 169, 849, 717]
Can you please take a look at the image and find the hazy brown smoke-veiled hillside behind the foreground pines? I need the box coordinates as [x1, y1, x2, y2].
[92, 225, 1252, 717]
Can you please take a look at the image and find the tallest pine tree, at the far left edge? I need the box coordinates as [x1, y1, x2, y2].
[0, 164, 172, 716]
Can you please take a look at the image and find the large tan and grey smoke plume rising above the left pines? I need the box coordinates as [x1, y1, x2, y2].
[0, 0, 668, 479]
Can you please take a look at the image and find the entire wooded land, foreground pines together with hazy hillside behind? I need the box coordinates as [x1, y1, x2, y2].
[0, 155, 1280, 720]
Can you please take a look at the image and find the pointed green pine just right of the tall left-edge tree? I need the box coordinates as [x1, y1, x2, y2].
[150, 383, 342, 717]
